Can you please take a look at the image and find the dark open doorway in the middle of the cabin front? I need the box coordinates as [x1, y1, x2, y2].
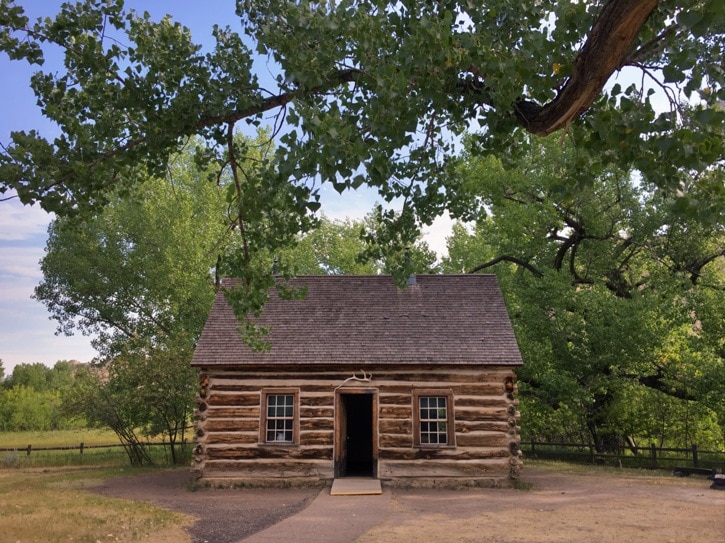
[338, 394, 375, 477]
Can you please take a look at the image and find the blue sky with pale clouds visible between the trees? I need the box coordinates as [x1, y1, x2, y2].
[0, 0, 451, 375]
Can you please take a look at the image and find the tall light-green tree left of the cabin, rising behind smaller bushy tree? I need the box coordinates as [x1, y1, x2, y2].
[35, 139, 229, 357]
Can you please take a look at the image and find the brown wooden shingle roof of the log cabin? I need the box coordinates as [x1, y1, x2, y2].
[192, 275, 522, 368]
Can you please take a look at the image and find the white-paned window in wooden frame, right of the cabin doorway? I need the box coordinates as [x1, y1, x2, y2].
[413, 390, 455, 447]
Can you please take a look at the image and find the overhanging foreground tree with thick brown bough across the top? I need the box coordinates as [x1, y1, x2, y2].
[0, 0, 725, 298]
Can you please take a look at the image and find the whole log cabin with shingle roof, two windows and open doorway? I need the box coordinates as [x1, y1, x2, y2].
[192, 275, 522, 487]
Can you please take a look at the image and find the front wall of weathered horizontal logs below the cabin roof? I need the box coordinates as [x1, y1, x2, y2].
[192, 366, 521, 486]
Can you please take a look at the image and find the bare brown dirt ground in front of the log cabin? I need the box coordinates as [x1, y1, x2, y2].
[95, 469, 725, 543]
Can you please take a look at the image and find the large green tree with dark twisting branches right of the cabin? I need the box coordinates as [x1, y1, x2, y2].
[443, 140, 725, 450]
